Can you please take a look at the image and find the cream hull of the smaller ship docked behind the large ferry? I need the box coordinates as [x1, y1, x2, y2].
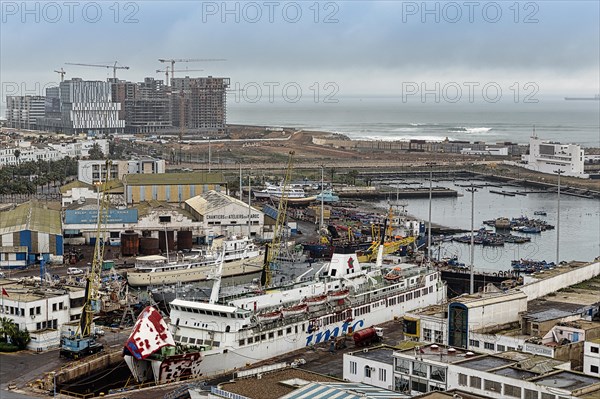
[127, 255, 263, 287]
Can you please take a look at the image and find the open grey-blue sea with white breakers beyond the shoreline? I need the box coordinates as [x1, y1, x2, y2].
[227, 97, 600, 147]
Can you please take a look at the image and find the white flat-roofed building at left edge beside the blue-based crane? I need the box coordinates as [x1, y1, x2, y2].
[0, 279, 85, 352]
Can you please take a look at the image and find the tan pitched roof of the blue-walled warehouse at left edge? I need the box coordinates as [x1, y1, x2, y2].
[0, 201, 62, 235]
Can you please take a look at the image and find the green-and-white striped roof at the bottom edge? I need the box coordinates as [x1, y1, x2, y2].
[281, 382, 410, 399]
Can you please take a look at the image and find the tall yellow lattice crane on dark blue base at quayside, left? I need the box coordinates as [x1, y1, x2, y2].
[59, 160, 112, 359]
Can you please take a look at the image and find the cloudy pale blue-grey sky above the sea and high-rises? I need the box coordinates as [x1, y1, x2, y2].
[0, 0, 600, 102]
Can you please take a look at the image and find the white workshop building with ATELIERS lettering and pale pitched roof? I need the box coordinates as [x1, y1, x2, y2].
[184, 190, 265, 236]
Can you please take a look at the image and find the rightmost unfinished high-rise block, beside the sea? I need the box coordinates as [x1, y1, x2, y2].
[171, 76, 229, 136]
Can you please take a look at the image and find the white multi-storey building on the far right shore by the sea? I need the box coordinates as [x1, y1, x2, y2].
[522, 132, 589, 178]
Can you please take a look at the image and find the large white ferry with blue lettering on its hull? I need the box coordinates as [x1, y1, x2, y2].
[125, 251, 446, 382]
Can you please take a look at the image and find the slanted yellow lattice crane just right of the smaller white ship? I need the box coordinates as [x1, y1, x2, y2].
[261, 151, 294, 287]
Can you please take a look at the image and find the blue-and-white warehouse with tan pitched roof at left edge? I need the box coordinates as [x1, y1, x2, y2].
[0, 201, 63, 268]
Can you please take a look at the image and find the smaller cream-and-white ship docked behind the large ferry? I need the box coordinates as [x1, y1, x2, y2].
[127, 236, 263, 287]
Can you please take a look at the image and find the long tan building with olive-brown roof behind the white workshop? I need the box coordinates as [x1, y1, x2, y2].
[123, 172, 227, 205]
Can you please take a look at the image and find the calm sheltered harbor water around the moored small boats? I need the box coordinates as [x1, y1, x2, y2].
[377, 180, 600, 271]
